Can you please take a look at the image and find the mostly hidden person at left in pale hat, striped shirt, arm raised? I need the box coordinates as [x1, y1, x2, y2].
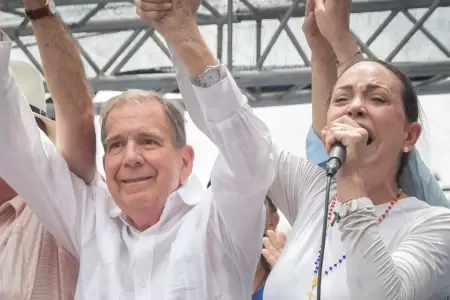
[0, 0, 95, 300]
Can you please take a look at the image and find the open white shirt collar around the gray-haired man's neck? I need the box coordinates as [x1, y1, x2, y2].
[108, 174, 206, 219]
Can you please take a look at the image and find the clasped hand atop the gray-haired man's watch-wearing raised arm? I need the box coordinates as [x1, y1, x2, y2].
[134, 0, 201, 41]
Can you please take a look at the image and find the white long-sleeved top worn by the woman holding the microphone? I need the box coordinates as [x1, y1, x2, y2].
[264, 150, 450, 300]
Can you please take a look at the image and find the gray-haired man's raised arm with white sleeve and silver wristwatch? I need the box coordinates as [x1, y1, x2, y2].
[136, 0, 273, 266]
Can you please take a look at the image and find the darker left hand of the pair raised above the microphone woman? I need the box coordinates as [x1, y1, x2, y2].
[302, 0, 334, 60]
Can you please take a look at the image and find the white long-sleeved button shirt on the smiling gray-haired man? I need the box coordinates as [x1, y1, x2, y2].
[0, 42, 273, 300]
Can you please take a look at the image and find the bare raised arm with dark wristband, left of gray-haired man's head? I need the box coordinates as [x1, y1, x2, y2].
[24, 0, 96, 183]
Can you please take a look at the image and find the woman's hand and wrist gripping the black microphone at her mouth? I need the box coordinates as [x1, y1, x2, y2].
[322, 116, 369, 203]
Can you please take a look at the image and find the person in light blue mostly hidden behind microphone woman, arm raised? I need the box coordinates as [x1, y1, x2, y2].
[303, 2, 450, 208]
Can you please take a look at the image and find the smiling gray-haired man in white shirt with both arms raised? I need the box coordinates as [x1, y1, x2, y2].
[0, 0, 273, 300]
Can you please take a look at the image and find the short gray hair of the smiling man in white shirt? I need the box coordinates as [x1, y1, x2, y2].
[100, 90, 186, 148]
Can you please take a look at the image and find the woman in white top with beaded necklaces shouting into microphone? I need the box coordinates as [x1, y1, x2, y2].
[264, 0, 450, 300]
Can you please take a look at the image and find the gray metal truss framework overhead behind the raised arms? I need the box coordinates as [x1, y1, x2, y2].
[3, 0, 450, 105]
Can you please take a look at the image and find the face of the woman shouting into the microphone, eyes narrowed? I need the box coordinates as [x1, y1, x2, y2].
[327, 61, 421, 176]
